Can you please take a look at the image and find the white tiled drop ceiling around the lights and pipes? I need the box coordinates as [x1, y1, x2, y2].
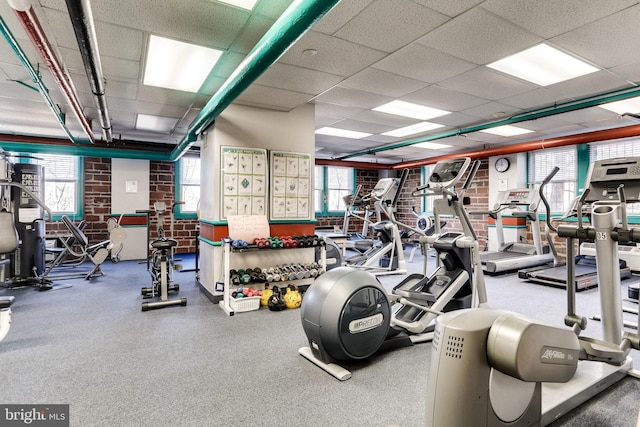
[0, 0, 640, 163]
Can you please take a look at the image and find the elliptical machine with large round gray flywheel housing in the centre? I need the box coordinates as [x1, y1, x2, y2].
[298, 158, 487, 381]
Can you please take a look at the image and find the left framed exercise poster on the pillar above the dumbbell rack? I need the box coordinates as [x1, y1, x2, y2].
[220, 147, 268, 220]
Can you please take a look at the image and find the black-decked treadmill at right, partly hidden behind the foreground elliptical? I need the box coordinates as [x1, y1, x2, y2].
[518, 177, 631, 292]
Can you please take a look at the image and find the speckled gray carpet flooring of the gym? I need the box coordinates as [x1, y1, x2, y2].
[0, 251, 640, 427]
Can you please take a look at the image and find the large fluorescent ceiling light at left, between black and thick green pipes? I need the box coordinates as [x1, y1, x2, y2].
[143, 35, 222, 93]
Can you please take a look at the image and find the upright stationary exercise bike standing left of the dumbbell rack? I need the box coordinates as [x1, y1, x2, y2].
[138, 202, 187, 311]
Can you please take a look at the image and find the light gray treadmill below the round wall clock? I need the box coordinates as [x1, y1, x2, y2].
[474, 188, 553, 274]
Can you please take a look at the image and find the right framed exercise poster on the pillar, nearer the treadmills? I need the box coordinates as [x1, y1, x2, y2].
[269, 151, 313, 220]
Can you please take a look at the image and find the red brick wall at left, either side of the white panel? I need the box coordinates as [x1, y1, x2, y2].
[47, 157, 197, 253]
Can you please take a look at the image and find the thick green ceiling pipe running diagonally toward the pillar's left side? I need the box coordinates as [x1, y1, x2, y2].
[171, 0, 340, 161]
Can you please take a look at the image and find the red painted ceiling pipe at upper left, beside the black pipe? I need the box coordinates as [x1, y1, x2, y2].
[9, 2, 95, 144]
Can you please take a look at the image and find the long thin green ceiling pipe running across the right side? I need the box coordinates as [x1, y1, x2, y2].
[335, 83, 640, 160]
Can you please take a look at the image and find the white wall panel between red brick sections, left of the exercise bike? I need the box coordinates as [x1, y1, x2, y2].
[111, 159, 149, 260]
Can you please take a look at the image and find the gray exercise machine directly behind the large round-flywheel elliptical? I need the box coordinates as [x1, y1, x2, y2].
[345, 170, 409, 275]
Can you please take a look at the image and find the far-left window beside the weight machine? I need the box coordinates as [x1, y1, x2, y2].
[33, 154, 82, 219]
